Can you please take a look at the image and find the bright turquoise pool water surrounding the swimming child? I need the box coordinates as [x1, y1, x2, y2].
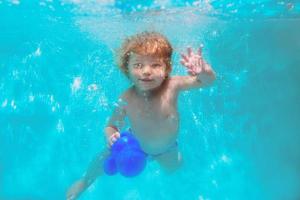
[0, 0, 300, 200]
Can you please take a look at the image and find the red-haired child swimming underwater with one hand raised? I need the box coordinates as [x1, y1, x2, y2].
[67, 32, 216, 200]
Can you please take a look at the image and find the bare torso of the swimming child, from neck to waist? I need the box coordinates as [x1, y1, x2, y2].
[124, 80, 179, 154]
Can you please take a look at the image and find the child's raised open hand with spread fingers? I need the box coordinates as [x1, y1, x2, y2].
[180, 47, 213, 76]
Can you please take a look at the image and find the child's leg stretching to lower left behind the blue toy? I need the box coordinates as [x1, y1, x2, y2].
[66, 149, 110, 200]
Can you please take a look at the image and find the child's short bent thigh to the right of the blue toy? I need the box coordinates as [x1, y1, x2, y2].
[154, 147, 182, 172]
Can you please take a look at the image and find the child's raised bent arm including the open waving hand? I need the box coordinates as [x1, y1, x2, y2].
[172, 47, 216, 90]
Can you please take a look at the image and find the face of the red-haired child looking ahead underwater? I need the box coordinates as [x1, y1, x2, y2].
[128, 53, 167, 91]
